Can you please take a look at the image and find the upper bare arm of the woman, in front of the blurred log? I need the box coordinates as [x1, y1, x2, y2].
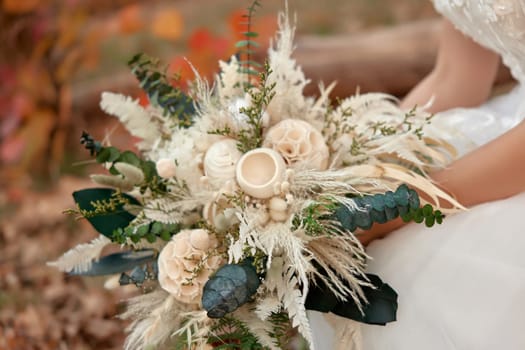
[401, 20, 499, 112]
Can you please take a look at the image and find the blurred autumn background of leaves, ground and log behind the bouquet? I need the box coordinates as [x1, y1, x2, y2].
[0, 0, 437, 349]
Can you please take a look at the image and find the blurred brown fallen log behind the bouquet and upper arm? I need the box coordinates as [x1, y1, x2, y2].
[294, 20, 512, 97]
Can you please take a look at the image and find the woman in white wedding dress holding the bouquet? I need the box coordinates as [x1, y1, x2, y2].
[312, 0, 525, 350]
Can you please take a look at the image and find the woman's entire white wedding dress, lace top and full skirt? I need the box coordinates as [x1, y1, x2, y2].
[310, 0, 525, 350]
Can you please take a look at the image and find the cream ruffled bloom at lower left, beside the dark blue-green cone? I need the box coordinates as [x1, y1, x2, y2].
[158, 229, 220, 304]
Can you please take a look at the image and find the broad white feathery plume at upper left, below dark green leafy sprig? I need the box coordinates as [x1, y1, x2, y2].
[100, 92, 160, 147]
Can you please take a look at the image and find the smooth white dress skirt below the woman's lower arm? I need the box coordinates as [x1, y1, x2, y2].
[361, 194, 525, 350]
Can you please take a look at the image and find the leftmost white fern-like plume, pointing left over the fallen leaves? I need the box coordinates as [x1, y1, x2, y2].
[47, 235, 111, 273]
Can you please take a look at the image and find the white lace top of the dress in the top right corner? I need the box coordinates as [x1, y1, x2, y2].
[433, 0, 525, 84]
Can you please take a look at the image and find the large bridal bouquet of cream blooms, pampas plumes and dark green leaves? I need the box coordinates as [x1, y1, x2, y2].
[52, 4, 453, 349]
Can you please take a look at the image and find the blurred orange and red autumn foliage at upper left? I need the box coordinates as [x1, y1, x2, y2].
[0, 0, 276, 190]
